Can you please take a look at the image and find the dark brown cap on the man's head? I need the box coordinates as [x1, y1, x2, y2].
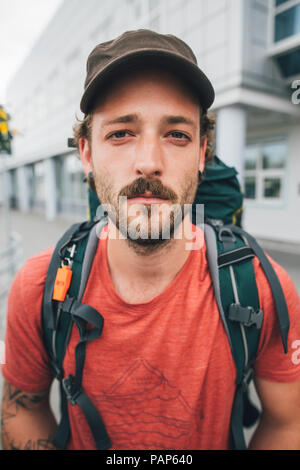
[80, 29, 215, 114]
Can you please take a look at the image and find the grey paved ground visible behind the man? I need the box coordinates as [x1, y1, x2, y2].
[0, 208, 300, 448]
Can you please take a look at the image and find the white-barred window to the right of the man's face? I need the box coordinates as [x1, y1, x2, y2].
[244, 141, 288, 201]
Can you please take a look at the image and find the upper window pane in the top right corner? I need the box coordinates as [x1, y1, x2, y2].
[274, 1, 300, 42]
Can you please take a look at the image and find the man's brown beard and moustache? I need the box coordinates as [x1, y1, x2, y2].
[94, 165, 200, 255]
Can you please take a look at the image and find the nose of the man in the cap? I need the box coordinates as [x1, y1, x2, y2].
[134, 135, 163, 178]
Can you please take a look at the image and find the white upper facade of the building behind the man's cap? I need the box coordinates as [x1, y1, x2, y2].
[8, 0, 254, 163]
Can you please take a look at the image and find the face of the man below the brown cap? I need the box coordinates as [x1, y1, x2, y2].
[80, 70, 205, 250]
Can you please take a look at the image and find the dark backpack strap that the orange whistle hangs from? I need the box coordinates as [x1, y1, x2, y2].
[42, 219, 111, 449]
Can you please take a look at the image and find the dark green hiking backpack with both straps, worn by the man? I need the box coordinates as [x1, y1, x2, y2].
[42, 157, 289, 450]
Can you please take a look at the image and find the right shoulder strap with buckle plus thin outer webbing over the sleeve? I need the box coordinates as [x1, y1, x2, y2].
[205, 225, 289, 449]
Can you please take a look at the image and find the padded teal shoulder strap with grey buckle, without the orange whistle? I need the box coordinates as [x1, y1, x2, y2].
[204, 225, 263, 449]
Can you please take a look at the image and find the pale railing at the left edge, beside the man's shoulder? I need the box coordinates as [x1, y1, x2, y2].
[0, 232, 23, 328]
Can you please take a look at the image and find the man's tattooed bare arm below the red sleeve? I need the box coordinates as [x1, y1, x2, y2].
[1, 382, 57, 450]
